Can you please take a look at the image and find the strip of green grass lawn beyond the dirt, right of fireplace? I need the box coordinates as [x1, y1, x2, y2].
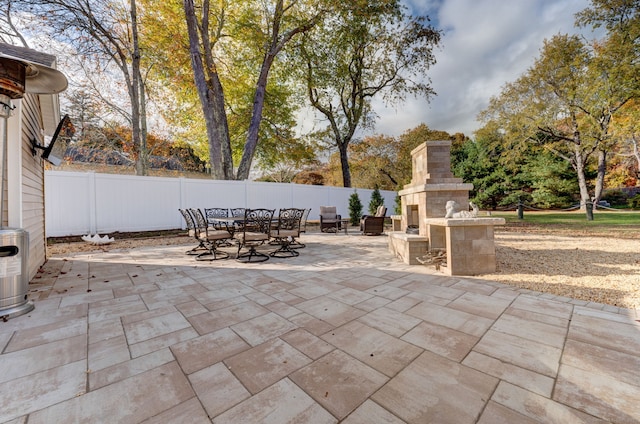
[491, 210, 640, 238]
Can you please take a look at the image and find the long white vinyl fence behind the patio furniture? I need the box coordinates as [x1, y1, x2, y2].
[44, 171, 396, 237]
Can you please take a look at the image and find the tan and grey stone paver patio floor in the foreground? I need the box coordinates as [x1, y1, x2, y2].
[0, 233, 640, 424]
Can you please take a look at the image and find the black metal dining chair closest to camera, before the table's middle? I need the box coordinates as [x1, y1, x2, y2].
[236, 209, 275, 262]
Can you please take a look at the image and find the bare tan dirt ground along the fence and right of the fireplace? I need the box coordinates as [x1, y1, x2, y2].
[48, 228, 640, 309]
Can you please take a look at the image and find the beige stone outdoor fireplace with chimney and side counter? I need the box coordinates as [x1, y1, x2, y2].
[389, 141, 504, 275]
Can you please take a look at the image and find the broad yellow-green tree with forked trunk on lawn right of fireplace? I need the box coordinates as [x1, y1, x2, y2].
[480, 35, 635, 218]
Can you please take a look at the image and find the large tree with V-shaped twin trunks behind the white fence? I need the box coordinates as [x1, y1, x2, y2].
[184, 0, 326, 180]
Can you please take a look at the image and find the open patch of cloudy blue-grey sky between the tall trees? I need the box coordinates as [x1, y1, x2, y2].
[374, 0, 592, 138]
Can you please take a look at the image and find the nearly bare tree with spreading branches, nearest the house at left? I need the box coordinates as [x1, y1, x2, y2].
[15, 0, 148, 175]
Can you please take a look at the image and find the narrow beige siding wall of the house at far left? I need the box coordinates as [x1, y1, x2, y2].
[21, 94, 46, 279]
